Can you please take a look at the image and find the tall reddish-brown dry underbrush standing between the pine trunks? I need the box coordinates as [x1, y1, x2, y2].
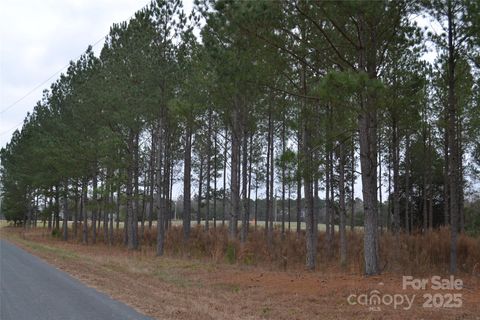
[4, 222, 480, 275]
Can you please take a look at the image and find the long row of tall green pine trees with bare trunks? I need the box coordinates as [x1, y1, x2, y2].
[1, 0, 480, 275]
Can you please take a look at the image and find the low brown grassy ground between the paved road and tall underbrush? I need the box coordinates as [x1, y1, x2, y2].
[0, 227, 480, 320]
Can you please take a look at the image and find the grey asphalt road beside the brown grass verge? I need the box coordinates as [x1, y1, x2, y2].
[0, 240, 149, 320]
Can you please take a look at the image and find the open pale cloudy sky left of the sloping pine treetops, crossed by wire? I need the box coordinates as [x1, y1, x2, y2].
[0, 0, 197, 148]
